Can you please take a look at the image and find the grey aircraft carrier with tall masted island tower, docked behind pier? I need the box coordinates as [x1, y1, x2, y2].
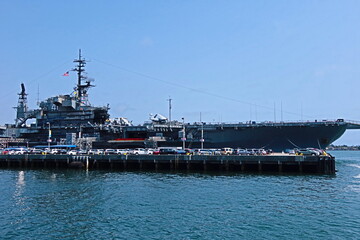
[5, 51, 358, 151]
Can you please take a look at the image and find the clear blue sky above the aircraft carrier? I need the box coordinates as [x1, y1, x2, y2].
[0, 0, 360, 144]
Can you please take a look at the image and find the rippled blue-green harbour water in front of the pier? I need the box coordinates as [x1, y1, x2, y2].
[0, 151, 360, 239]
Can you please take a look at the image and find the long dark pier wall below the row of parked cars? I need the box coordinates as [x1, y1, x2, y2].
[0, 154, 335, 174]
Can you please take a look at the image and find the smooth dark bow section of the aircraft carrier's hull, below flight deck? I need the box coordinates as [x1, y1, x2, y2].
[181, 124, 346, 151]
